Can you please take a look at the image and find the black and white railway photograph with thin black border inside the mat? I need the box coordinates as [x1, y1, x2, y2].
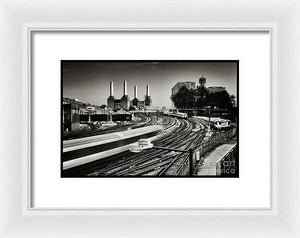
[61, 60, 242, 178]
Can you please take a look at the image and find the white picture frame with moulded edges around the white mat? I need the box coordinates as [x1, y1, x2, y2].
[0, 0, 300, 237]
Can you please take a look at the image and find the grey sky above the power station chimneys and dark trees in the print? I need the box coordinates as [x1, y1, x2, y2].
[62, 61, 237, 107]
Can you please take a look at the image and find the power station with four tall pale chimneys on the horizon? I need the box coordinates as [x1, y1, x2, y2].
[107, 81, 152, 110]
